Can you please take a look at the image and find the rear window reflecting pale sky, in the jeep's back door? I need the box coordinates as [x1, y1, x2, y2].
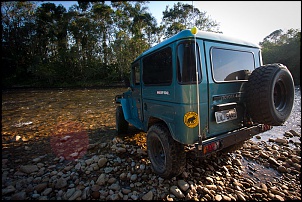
[212, 48, 255, 82]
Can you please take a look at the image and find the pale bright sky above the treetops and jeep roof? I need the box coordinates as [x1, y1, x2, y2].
[44, 1, 301, 44]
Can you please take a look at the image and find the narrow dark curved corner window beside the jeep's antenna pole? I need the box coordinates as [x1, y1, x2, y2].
[177, 41, 201, 84]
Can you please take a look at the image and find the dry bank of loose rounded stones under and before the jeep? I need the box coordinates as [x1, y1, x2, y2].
[2, 130, 301, 201]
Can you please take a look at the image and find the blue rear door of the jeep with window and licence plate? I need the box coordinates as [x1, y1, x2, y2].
[205, 42, 259, 137]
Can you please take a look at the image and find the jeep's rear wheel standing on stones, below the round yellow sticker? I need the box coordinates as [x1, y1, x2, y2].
[147, 124, 186, 179]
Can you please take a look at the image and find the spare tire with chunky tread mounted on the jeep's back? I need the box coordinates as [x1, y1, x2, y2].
[245, 64, 295, 126]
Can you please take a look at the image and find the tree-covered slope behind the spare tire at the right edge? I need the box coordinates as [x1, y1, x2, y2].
[260, 29, 301, 85]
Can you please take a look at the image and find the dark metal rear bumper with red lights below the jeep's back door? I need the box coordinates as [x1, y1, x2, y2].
[195, 124, 272, 156]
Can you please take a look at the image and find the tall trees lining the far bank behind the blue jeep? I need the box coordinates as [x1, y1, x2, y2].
[1, 1, 301, 87]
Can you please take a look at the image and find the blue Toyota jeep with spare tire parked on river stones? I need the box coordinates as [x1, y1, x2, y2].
[115, 30, 294, 178]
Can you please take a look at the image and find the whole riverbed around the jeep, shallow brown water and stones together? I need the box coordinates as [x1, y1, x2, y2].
[1, 88, 301, 201]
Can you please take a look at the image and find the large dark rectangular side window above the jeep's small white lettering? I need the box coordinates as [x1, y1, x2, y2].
[143, 47, 172, 85]
